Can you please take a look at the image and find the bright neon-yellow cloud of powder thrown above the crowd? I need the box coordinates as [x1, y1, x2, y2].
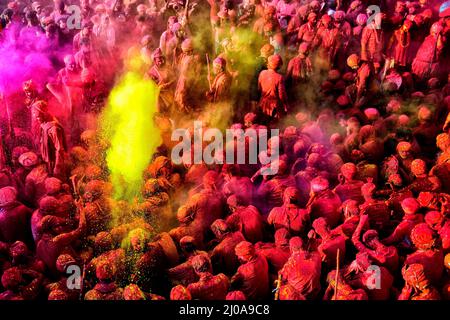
[100, 71, 161, 202]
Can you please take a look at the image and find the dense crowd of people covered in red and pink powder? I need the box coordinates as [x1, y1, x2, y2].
[0, 0, 450, 300]
